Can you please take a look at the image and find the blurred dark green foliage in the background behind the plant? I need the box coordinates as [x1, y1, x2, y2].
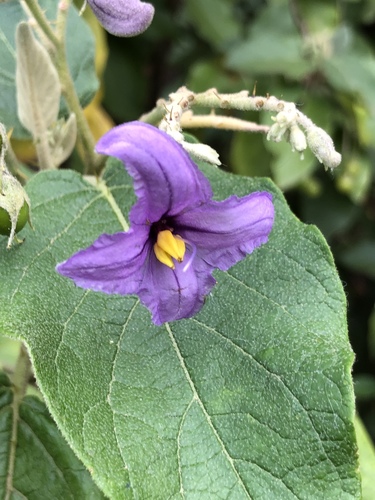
[0, 0, 375, 498]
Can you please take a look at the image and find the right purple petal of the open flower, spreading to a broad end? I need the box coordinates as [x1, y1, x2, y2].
[175, 192, 274, 271]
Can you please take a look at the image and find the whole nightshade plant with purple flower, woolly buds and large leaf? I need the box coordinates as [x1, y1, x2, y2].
[0, 0, 365, 500]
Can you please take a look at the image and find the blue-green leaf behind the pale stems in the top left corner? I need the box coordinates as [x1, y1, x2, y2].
[0, 0, 98, 139]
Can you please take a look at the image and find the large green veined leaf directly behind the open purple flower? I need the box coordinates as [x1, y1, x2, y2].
[0, 163, 360, 500]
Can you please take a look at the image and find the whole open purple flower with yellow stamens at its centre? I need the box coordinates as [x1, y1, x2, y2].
[57, 122, 274, 325]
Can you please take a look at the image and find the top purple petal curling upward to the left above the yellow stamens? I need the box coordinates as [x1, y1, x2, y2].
[96, 122, 212, 224]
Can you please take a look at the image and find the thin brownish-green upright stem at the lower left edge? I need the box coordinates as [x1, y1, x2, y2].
[5, 344, 32, 500]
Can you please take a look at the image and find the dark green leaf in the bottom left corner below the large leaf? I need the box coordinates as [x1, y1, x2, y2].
[0, 373, 104, 500]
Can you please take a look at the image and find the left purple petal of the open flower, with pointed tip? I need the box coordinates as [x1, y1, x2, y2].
[56, 227, 151, 295]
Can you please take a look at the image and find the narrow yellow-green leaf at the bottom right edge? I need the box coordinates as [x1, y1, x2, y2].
[354, 417, 375, 500]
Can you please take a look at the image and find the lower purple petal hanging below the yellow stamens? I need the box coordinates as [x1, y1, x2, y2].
[138, 252, 216, 325]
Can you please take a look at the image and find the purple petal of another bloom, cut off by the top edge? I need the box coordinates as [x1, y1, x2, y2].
[87, 0, 154, 36]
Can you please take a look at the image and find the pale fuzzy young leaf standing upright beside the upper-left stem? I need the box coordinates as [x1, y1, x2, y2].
[16, 23, 61, 139]
